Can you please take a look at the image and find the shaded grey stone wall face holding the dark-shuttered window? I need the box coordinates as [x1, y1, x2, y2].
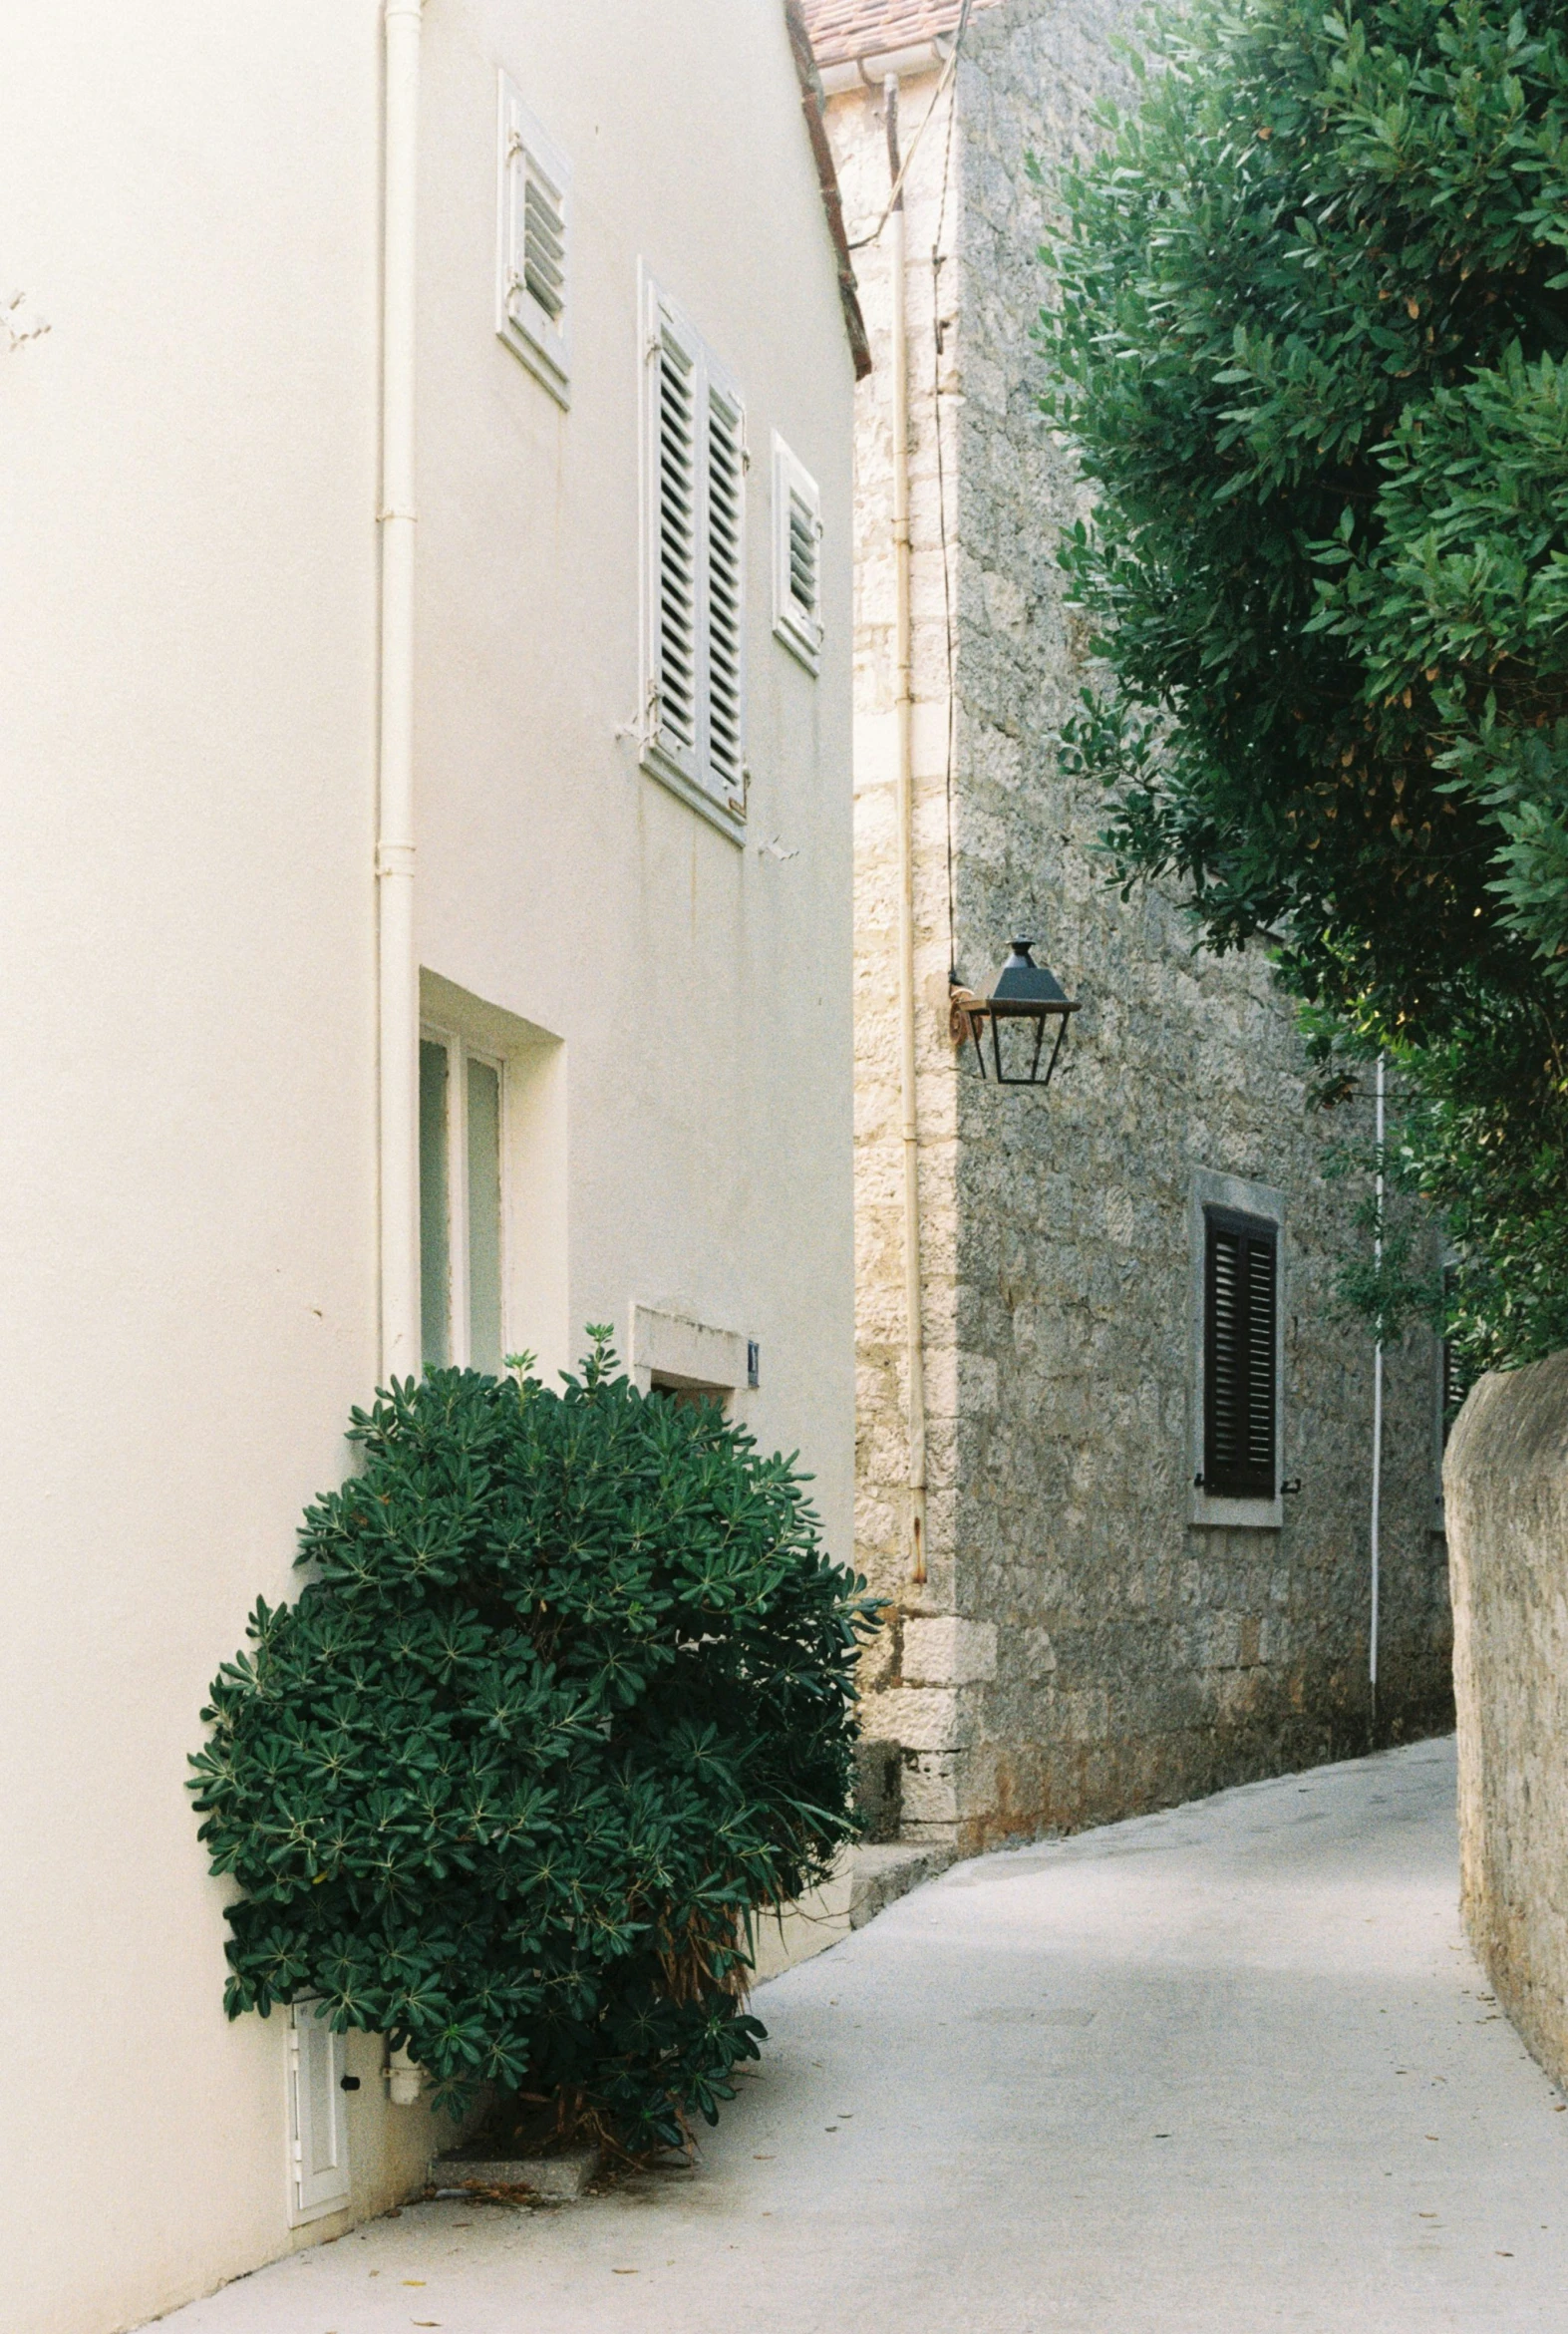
[954, 0, 1449, 1843]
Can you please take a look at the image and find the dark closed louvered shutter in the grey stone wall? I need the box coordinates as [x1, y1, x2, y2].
[1204, 1209, 1279, 1499]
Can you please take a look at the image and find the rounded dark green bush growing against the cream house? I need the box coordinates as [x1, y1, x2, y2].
[191, 1330, 875, 2150]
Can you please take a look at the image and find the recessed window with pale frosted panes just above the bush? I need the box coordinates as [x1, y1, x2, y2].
[420, 1029, 506, 1373]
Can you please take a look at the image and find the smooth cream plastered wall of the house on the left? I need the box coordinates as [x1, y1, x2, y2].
[0, 0, 851, 2334]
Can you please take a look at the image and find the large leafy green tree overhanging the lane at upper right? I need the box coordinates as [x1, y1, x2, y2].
[1041, 0, 1568, 1363]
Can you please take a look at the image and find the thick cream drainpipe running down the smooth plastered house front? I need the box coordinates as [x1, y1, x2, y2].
[376, 0, 423, 1384]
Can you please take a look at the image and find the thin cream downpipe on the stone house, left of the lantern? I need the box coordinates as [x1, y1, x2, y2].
[882, 73, 926, 1582]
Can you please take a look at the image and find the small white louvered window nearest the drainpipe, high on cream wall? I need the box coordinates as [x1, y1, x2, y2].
[494, 75, 571, 406]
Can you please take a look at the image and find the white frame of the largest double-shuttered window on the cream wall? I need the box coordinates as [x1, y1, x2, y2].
[637, 268, 752, 844]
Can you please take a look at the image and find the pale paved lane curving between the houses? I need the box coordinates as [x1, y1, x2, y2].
[163, 1741, 1568, 2334]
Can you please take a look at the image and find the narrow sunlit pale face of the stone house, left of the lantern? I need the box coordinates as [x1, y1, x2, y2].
[828, 59, 959, 1783]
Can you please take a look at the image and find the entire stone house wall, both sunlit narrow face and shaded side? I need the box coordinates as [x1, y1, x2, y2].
[830, 0, 1451, 1848]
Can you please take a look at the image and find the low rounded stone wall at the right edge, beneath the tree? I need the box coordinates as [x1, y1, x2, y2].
[1442, 1354, 1568, 2087]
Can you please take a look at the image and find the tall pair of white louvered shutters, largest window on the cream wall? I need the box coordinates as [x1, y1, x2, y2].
[644, 271, 747, 831]
